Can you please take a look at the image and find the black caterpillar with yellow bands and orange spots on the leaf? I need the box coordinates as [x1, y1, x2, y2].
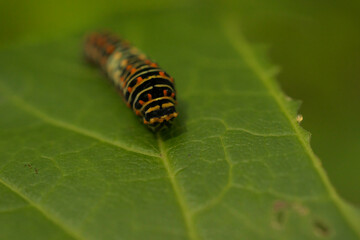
[84, 33, 178, 131]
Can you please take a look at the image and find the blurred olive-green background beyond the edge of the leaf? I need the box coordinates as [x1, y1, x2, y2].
[0, 0, 360, 206]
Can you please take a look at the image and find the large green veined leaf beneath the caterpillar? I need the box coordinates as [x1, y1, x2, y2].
[0, 5, 360, 240]
